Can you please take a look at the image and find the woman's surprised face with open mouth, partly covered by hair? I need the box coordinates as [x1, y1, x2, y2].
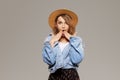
[57, 16, 69, 31]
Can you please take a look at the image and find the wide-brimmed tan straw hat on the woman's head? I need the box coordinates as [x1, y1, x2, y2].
[48, 9, 78, 28]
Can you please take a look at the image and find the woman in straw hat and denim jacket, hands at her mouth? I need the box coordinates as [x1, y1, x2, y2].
[42, 9, 84, 80]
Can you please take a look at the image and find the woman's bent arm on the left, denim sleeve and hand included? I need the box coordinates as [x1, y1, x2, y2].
[42, 31, 62, 65]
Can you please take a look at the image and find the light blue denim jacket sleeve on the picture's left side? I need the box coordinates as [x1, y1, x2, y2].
[42, 37, 56, 66]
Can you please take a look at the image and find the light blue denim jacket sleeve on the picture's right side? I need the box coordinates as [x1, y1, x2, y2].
[69, 37, 84, 65]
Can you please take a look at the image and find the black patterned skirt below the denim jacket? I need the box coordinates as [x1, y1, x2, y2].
[48, 68, 80, 80]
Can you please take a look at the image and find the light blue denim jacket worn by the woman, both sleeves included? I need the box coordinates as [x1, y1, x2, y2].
[42, 34, 84, 73]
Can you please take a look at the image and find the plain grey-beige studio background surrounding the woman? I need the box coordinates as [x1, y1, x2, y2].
[0, 0, 120, 80]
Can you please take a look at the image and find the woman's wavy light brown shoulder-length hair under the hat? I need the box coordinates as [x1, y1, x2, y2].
[53, 14, 75, 35]
